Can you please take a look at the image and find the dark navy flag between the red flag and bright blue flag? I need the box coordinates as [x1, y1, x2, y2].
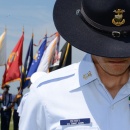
[21, 35, 33, 89]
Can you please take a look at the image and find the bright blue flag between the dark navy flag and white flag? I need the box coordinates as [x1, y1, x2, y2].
[23, 36, 47, 89]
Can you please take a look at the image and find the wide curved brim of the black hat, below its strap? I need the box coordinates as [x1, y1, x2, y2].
[53, 0, 130, 58]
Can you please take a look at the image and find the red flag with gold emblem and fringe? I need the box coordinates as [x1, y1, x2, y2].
[2, 33, 24, 88]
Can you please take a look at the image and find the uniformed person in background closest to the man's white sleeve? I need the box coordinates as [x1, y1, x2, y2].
[13, 87, 22, 130]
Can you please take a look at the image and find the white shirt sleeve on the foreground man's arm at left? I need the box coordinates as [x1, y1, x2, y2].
[19, 88, 46, 130]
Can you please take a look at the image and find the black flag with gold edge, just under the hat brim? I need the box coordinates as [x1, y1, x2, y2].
[49, 42, 72, 71]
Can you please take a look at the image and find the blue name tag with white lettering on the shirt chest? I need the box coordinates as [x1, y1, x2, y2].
[60, 118, 90, 125]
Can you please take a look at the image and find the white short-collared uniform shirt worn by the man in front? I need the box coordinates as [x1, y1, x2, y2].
[19, 54, 130, 130]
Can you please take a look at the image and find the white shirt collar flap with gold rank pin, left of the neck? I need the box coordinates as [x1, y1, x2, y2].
[71, 54, 99, 89]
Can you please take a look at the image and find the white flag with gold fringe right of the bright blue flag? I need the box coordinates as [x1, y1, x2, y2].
[37, 33, 60, 72]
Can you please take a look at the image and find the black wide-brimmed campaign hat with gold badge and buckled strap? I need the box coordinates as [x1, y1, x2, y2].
[53, 0, 130, 57]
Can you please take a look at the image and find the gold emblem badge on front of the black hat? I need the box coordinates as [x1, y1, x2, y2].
[112, 9, 125, 26]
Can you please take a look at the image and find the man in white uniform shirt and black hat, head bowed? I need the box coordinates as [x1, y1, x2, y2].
[19, 0, 130, 130]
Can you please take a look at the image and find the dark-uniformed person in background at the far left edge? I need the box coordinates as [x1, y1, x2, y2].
[1, 85, 13, 130]
